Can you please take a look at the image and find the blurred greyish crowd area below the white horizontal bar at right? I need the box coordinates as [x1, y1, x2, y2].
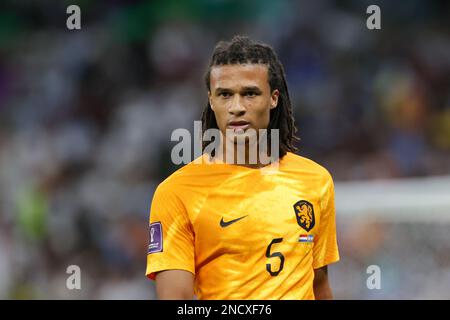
[329, 216, 450, 300]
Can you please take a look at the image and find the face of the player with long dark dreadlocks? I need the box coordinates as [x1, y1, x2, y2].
[208, 64, 279, 144]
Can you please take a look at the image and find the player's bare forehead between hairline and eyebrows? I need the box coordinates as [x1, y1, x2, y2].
[210, 64, 269, 90]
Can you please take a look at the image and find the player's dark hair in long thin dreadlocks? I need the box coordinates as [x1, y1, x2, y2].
[202, 36, 299, 158]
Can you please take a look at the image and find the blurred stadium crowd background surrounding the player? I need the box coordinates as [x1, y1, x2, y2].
[0, 0, 450, 299]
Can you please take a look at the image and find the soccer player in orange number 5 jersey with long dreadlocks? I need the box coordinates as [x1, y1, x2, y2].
[146, 36, 339, 299]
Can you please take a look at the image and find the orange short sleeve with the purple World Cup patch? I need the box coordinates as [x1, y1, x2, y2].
[146, 184, 195, 280]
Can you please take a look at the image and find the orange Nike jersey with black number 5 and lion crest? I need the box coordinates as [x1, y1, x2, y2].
[146, 153, 339, 299]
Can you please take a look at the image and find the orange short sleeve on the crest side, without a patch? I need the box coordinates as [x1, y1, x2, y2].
[313, 172, 339, 269]
